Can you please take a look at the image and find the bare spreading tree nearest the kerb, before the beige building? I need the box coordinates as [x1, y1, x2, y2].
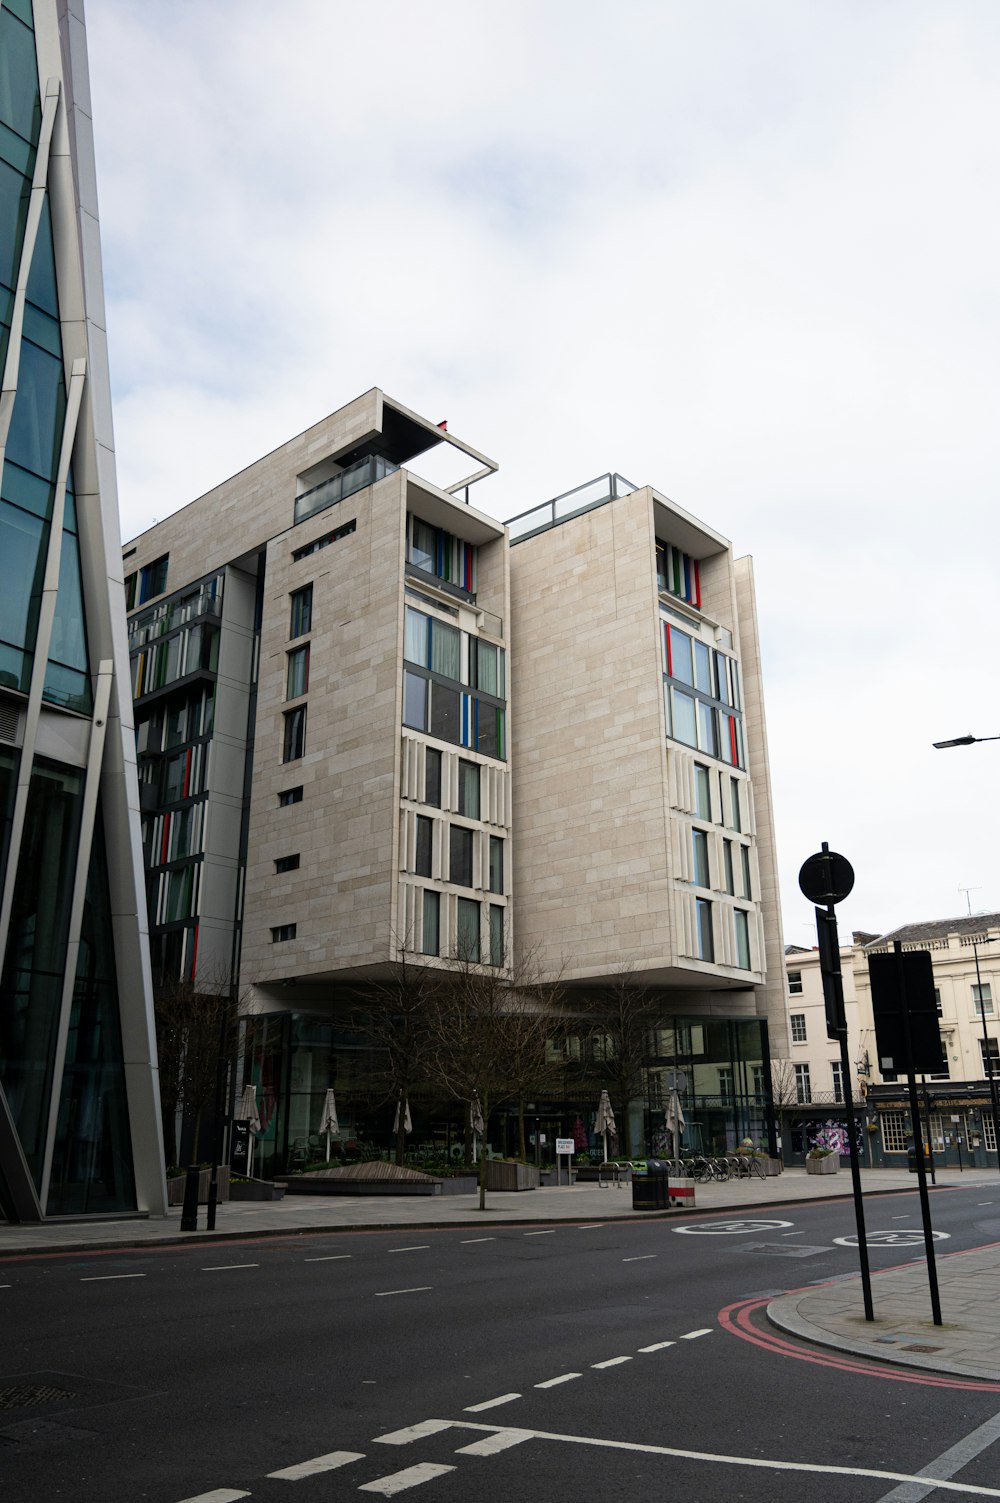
[429, 959, 552, 1210]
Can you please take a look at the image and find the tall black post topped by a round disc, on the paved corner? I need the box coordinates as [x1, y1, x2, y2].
[798, 840, 875, 1320]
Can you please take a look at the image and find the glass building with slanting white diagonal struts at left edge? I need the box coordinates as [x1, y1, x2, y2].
[0, 0, 164, 1220]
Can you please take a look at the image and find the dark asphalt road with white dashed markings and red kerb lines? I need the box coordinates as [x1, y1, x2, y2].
[0, 1184, 1000, 1503]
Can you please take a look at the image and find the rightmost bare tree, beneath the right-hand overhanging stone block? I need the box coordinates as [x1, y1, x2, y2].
[582, 965, 660, 1159]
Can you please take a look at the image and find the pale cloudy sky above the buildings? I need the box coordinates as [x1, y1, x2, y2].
[87, 0, 1000, 945]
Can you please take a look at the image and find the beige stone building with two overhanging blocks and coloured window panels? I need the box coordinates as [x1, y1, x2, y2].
[125, 405, 785, 1157]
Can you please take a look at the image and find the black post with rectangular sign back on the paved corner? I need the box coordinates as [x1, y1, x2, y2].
[868, 939, 941, 1326]
